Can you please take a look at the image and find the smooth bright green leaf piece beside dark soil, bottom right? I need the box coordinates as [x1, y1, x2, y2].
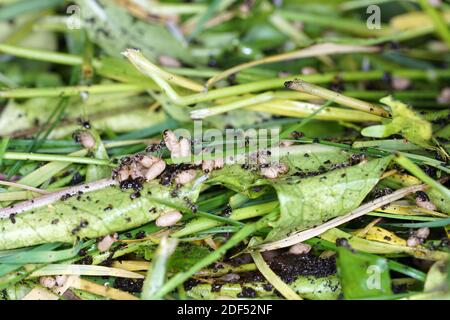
[336, 247, 393, 299]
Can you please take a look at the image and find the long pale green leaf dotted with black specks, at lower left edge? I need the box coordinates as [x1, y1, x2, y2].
[0, 180, 201, 250]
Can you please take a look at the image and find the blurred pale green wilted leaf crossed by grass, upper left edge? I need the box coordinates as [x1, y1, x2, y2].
[0, 93, 166, 138]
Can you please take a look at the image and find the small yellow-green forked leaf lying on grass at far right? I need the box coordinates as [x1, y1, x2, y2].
[361, 96, 433, 147]
